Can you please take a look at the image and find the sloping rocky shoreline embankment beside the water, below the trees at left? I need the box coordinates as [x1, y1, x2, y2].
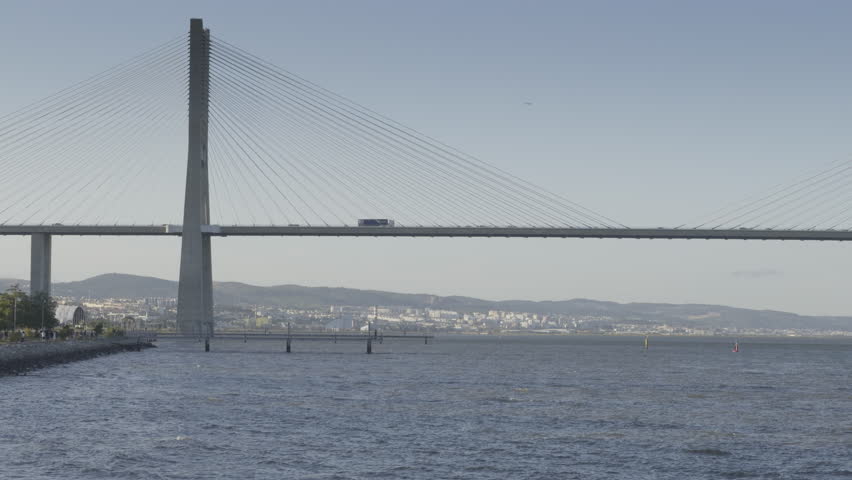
[0, 337, 154, 376]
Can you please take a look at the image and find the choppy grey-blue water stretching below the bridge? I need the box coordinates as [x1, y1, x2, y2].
[0, 337, 852, 479]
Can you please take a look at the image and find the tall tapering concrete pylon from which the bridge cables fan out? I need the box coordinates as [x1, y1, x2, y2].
[177, 18, 213, 337]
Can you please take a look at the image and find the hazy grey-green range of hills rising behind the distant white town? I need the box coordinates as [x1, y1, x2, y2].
[0, 273, 852, 331]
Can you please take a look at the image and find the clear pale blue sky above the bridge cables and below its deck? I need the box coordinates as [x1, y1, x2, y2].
[0, 0, 852, 315]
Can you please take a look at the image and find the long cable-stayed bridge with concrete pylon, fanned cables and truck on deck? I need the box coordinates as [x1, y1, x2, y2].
[0, 19, 852, 336]
